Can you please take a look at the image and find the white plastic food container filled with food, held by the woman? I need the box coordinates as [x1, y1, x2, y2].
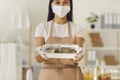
[43, 44, 82, 58]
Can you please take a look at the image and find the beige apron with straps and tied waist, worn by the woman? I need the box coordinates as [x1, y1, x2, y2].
[39, 22, 83, 80]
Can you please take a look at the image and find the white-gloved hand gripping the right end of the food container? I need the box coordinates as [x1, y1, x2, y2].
[73, 47, 84, 62]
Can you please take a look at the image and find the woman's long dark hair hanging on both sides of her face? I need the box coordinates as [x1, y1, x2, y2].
[47, 0, 73, 21]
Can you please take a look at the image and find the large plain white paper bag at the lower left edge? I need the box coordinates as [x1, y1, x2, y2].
[0, 43, 22, 80]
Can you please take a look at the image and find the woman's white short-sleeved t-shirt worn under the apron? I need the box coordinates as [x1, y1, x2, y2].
[35, 21, 85, 42]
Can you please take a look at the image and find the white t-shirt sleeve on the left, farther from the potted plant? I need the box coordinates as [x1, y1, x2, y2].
[35, 23, 44, 37]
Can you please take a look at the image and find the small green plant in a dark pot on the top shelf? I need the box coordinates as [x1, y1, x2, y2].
[86, 13, 99, 29]
